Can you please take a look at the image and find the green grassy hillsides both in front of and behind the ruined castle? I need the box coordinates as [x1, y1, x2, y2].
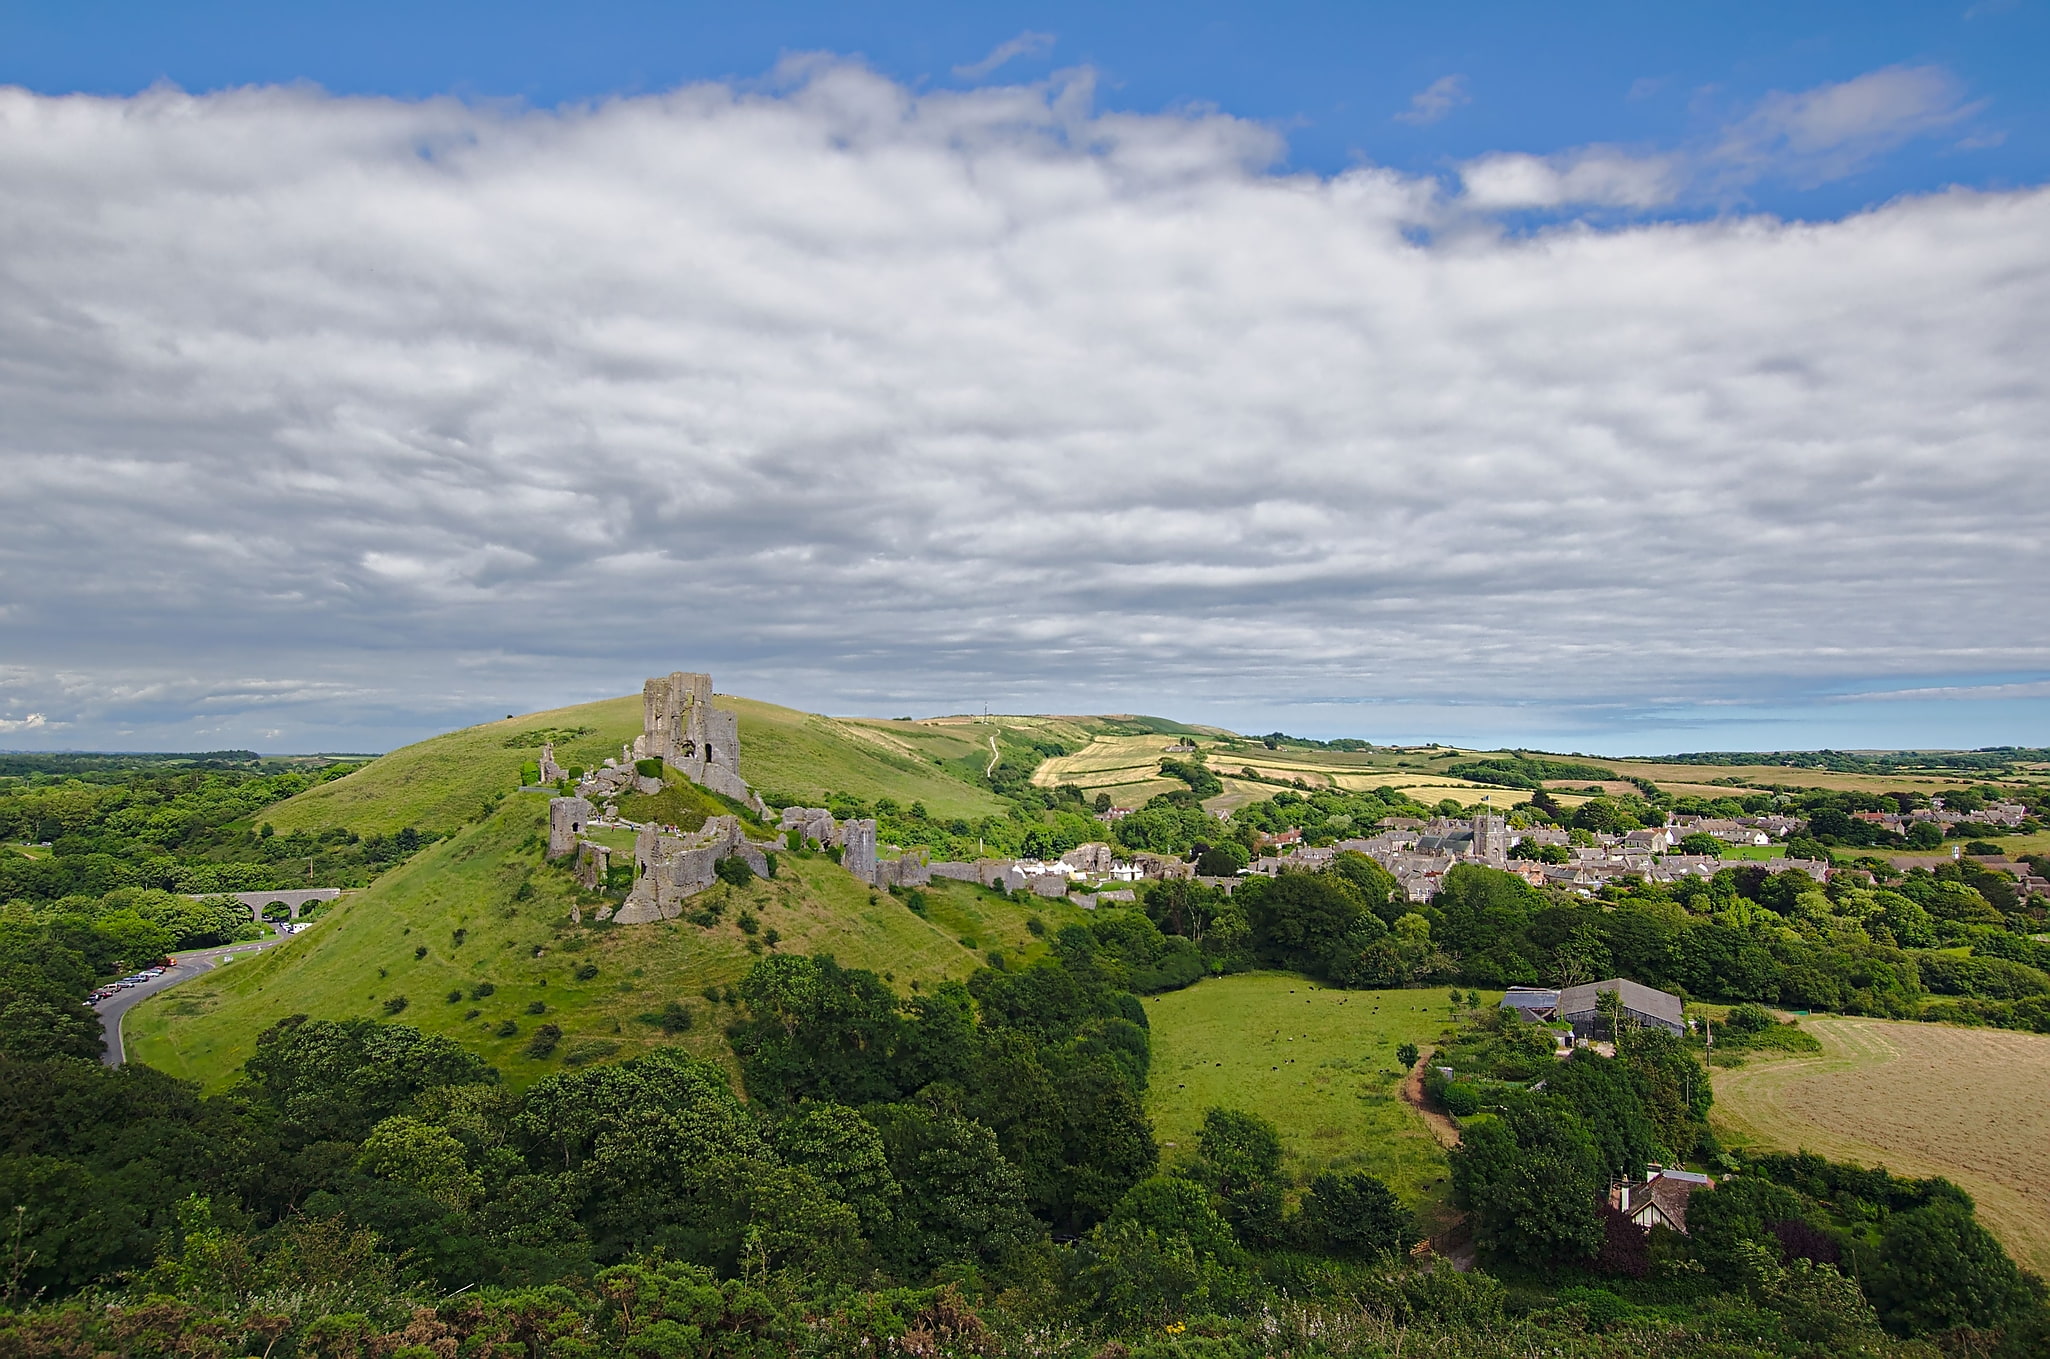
[125, 695, 1131, 1086]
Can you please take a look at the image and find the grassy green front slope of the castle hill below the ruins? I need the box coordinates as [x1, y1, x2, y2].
[125, 795, 1080, 1088]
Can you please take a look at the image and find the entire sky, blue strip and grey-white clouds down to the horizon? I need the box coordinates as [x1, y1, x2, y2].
[0, 0, 2050, 754]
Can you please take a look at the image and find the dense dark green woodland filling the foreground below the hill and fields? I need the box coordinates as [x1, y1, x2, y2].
[0, 926, 2050, 1357]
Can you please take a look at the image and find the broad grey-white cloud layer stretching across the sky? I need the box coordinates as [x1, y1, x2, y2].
[0, 59, 2050, 748]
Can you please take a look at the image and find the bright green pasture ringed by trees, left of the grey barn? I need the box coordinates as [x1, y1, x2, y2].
[1146, 972, 1484, 1230]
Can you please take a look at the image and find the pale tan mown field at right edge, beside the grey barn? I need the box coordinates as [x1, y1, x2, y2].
[1712, 1019, 2050, 1273]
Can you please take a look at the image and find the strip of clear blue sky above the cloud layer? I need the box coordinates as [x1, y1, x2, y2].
[0, 0, 2050, 217]
